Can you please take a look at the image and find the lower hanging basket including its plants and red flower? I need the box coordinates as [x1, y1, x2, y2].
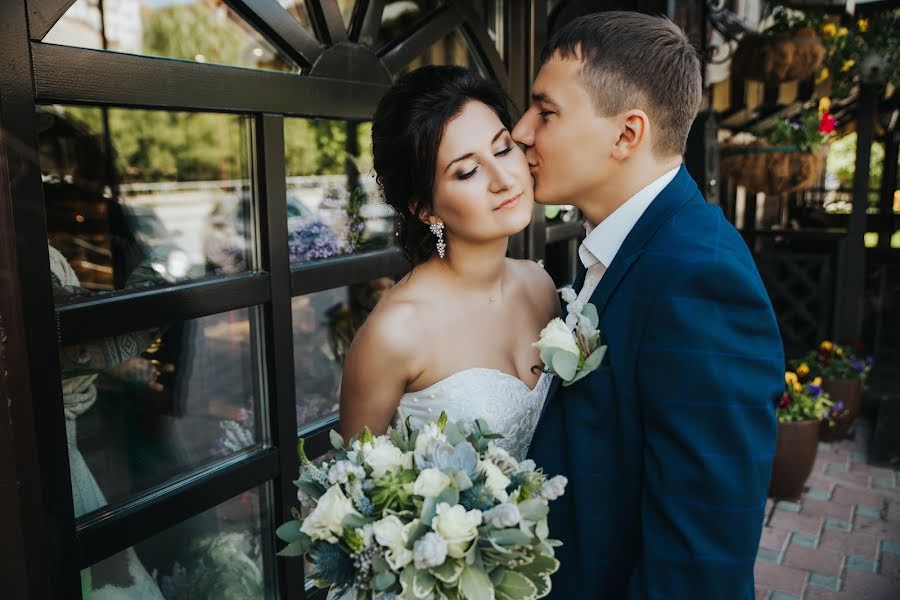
[720, 98, 837, 194]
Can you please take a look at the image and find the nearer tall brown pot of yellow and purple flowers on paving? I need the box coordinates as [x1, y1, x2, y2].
[769, 371, 832, 498]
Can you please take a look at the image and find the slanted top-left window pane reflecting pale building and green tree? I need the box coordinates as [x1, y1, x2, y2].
[44, 0, 299, 72]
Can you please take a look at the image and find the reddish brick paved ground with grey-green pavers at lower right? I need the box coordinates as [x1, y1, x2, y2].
[756, 422, 900, 600]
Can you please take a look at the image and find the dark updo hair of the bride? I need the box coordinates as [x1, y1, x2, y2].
[372, 66, 512, 266]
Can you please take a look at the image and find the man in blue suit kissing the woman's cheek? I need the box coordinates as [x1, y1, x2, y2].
[513, 12, 784, 600]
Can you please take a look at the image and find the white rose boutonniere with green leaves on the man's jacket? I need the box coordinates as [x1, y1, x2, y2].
[533, 288, 606, 385]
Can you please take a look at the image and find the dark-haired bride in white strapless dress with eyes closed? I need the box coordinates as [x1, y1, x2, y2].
[340, 66, 559, 458]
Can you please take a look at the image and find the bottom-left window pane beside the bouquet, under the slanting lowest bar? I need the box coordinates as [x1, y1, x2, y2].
[81, 488, 274, 600]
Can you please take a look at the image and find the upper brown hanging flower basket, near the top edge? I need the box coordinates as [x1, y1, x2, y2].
[731, 27, 825, 83]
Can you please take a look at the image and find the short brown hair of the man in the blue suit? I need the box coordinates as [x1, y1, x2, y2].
[541, 11, 703, 156]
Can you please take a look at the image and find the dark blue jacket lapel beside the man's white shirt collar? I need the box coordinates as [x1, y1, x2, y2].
[590, 165, 699, 315]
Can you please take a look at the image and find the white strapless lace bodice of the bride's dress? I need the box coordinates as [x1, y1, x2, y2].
[394, 368, 551, 459]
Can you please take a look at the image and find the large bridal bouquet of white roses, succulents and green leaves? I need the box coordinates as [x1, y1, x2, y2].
[277, 413, 566, 600]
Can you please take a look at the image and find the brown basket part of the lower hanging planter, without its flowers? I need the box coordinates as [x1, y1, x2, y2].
[719, 140, 828, 194]
